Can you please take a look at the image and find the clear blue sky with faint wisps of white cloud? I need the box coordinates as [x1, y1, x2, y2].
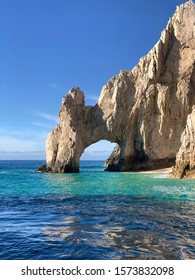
[0, 0, 184, 159]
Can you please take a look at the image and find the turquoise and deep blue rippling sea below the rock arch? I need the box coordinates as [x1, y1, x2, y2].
[0, 161, 195, 260]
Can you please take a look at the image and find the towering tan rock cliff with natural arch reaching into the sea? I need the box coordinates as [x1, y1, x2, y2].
[46, 1, 195, 172]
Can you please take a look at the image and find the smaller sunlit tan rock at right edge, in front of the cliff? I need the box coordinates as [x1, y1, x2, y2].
[171, 106, 195, 178]
